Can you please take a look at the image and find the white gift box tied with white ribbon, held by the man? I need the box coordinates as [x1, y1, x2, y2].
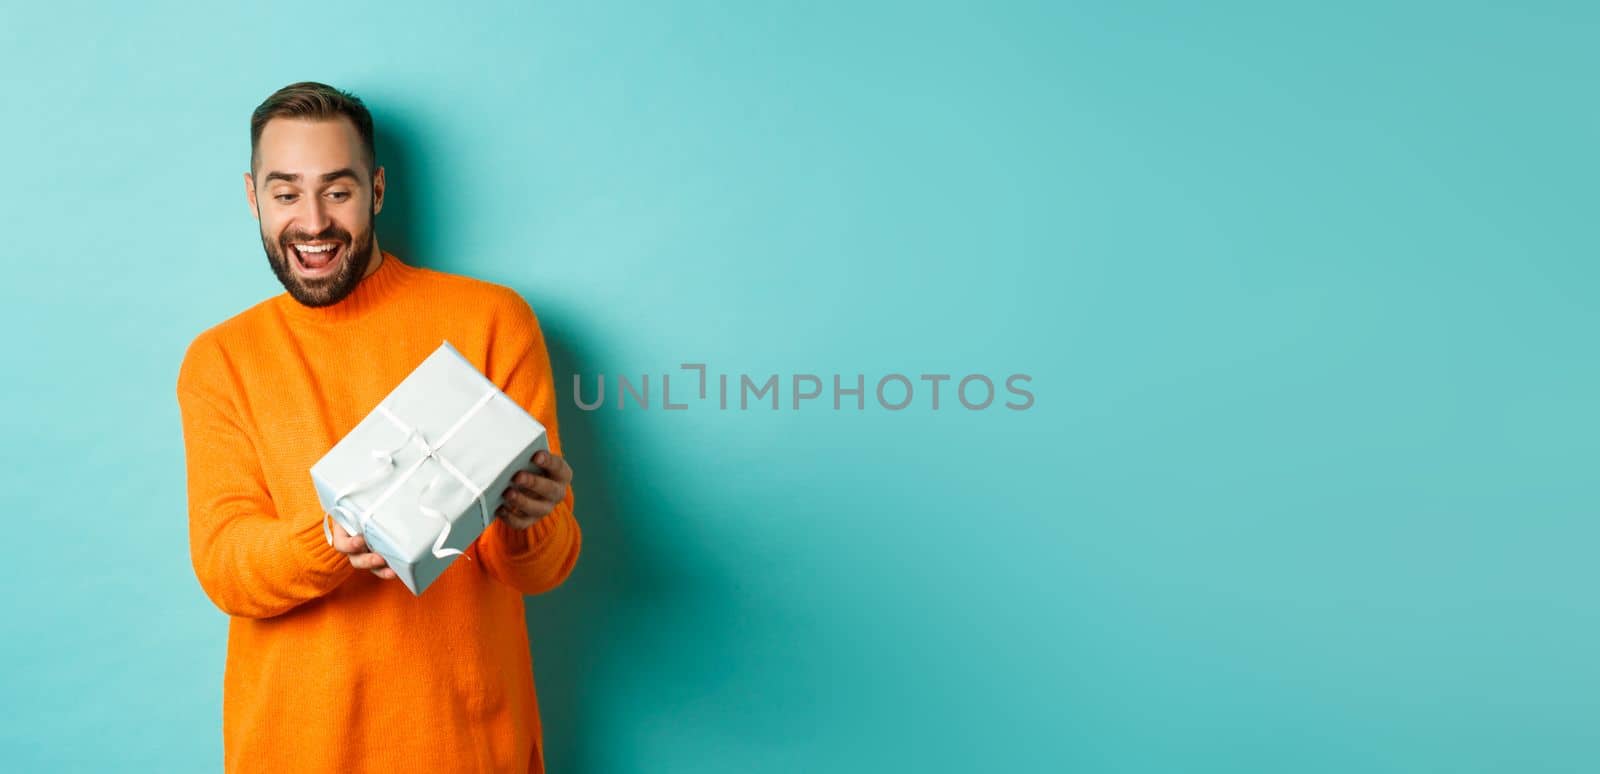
[310, 341, 549, 595]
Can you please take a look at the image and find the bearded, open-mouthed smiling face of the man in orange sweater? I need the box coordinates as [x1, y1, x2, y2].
[245, 117, 384, 307]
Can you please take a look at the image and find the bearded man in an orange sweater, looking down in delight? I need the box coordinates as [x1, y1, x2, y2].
[178, 82, 582, 774]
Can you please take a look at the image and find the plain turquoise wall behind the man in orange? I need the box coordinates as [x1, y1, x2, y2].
[0, 2, 1600, 774]
